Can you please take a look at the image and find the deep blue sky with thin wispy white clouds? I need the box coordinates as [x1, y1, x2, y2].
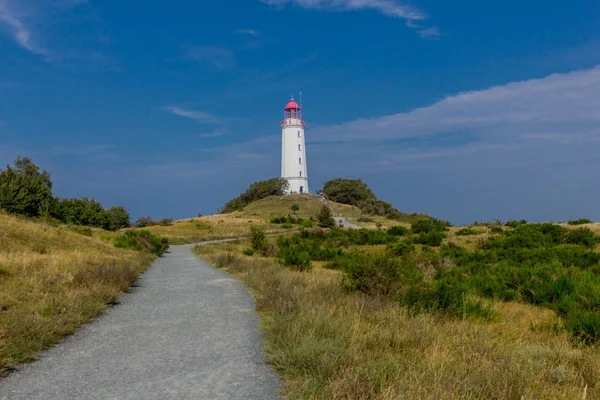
[0, 0, 600, 224]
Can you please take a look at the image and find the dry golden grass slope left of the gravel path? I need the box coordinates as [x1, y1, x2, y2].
[0, 214, 154, 373]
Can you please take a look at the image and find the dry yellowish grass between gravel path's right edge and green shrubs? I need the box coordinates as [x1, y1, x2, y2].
[196, 243, 600, 399]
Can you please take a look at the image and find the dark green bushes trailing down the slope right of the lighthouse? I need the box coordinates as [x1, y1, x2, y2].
[322, 178, 428, 223]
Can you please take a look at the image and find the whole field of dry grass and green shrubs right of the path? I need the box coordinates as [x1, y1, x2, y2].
[195, 219, 600, 399]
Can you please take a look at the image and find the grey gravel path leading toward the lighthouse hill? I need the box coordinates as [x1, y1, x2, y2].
[0, 245, 279, 400]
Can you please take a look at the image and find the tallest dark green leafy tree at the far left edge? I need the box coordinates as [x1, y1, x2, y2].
[0, 156, 54, 217]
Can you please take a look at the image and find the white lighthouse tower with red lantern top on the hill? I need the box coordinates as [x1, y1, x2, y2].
[281, 97, 308, 193]
